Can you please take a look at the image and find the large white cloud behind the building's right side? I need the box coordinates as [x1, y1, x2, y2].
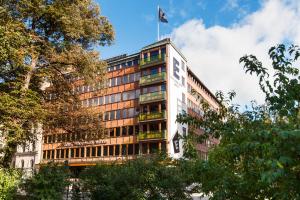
[171, 0, 300, 104]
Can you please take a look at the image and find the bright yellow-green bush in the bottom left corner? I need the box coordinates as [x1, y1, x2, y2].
[0, 169, 21, 200]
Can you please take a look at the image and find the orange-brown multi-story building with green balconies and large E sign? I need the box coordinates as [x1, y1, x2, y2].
[42, 39, 218, 166]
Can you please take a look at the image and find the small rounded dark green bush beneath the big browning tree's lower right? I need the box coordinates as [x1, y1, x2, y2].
[22, 163, 70, 200]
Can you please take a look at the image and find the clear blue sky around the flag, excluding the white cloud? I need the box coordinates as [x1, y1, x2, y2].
[97, 0, 260, 58]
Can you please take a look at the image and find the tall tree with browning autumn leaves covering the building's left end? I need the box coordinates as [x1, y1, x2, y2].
[0, 0, 114, 167]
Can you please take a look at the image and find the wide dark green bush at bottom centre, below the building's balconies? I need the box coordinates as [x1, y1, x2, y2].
[81, 157, 190, 200]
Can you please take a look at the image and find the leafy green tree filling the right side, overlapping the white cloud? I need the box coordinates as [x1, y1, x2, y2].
[179, 45, 300, 200]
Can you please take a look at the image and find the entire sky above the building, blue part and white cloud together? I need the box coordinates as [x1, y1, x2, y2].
[97, 0, 300, 105]
